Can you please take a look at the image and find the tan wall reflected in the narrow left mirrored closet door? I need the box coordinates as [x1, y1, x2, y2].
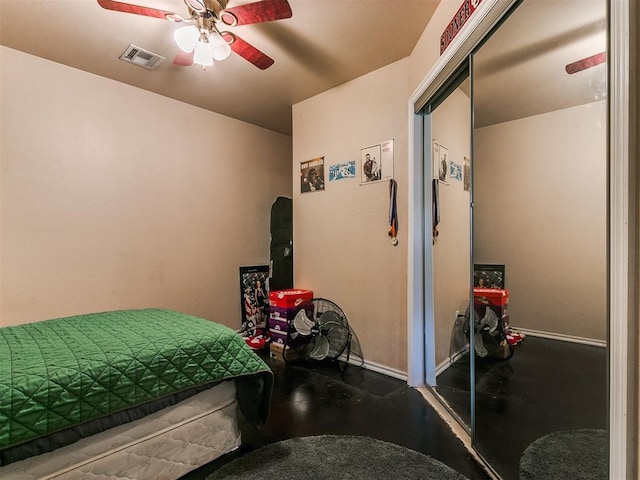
[431, 89, 471, 366]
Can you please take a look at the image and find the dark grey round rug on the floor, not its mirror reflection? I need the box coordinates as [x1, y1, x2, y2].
[207, 435, 466, 480]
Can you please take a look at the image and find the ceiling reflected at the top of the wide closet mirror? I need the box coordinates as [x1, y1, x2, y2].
[473, 0, 607, 128]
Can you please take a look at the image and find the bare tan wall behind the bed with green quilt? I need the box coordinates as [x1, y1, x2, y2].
[0, 47, 291, 328]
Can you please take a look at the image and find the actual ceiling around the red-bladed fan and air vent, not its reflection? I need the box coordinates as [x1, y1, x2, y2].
[0, 0, 439, 134]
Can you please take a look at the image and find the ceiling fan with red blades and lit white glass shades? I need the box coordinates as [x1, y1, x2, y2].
[97, 0, 292, 70]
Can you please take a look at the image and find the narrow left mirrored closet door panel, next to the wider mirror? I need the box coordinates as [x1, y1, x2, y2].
[431, 77, 471, 430]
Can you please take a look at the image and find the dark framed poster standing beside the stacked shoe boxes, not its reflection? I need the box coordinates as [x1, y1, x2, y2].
[240, 265, 269, 331]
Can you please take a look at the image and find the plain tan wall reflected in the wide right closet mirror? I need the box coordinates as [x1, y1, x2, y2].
[473, 102, 607, 341]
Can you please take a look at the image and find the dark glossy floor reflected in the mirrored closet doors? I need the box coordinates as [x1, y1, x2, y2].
[437, 337, 608, 480]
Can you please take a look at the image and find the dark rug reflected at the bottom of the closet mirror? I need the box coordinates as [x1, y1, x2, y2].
[520, 429, 608, 480]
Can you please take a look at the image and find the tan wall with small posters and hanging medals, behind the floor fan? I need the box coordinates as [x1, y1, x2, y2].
[293, 60, 408, 371]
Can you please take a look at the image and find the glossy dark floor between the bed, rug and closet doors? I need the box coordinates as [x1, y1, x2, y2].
[182, 353, 489, 480]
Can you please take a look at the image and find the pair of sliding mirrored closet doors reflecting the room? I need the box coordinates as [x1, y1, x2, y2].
[425, 0, 608, 479]
